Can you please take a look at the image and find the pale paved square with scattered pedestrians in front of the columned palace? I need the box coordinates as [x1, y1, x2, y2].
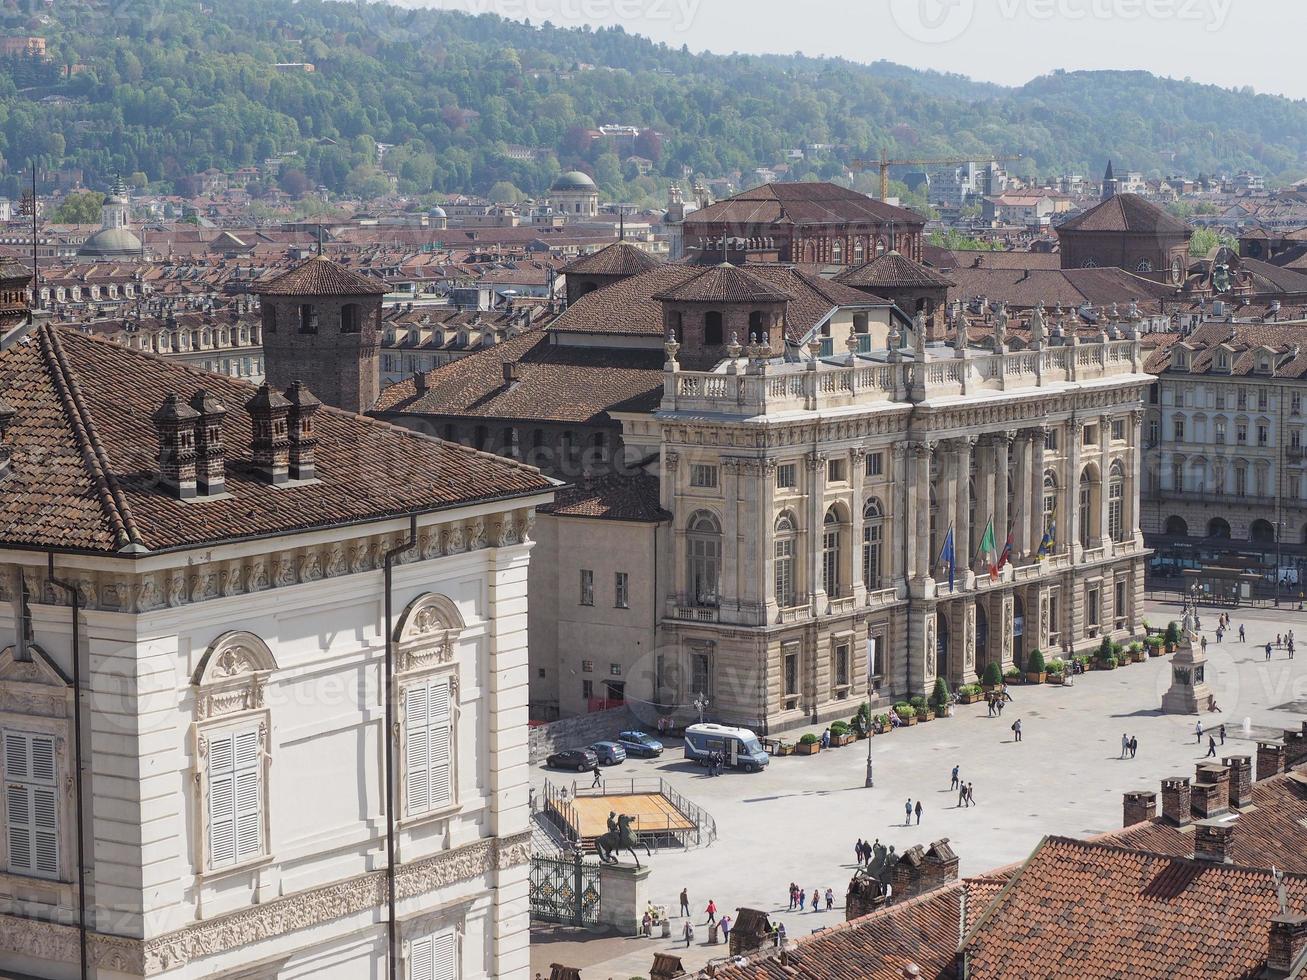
[532, 604, 1307, 980]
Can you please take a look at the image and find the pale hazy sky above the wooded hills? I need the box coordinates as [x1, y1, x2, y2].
[396, 0, 1307, 100]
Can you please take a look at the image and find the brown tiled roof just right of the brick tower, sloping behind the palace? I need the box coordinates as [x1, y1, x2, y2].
[372, 331, 665, 422]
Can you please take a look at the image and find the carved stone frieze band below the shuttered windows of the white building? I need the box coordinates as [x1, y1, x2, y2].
[0, 831, 531, 977]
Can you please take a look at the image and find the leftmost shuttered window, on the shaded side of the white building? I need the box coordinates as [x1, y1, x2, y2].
[4, 732, 59, 878]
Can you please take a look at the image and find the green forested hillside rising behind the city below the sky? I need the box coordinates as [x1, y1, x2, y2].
[0, 0, 1307, 201]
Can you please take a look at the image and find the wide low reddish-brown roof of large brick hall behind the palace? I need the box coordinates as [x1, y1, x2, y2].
[685, 183, 925, 234]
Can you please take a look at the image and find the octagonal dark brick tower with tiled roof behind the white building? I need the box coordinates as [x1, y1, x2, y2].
[254, 255, 386, 413]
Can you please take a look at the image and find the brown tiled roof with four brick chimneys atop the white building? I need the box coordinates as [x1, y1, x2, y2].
[0, 325, 552, 553]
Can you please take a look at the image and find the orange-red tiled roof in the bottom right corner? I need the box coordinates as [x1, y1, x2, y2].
[963, 838, 1307, 980]
